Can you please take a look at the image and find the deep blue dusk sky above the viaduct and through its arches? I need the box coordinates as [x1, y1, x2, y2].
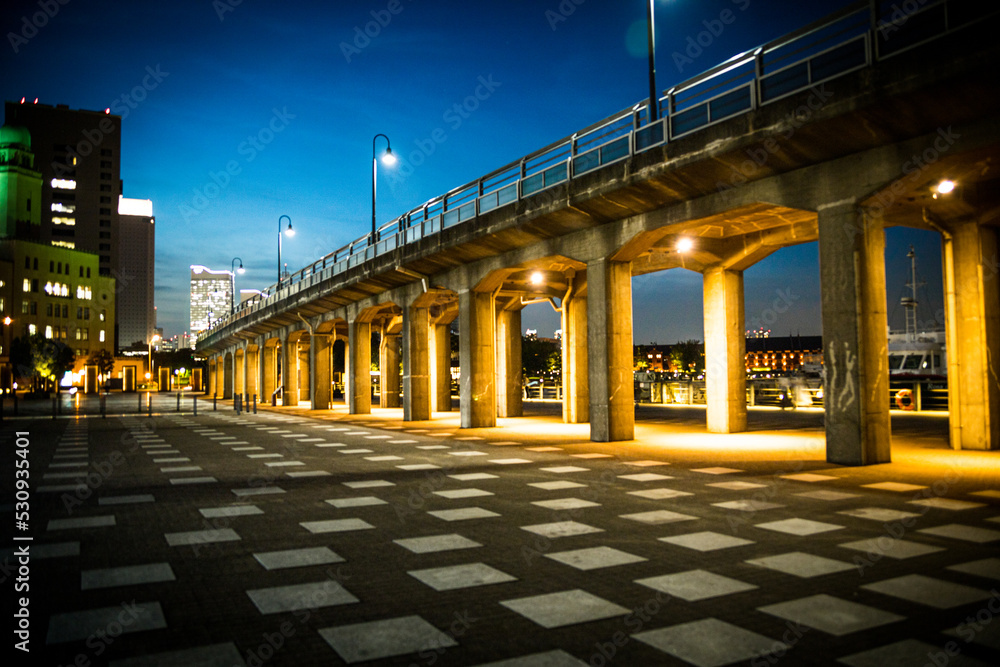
[0, 0, 940, 343]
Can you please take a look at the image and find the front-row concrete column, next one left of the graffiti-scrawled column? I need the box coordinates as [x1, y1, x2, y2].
[587, 259, 635, 442]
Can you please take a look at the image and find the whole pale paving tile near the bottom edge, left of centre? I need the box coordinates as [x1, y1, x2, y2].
[318, 616, 458, 664]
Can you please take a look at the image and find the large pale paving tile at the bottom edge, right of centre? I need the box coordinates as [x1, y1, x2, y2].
[632, 618, 786, 667]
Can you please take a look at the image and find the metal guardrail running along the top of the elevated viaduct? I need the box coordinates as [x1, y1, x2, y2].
[199, 0, 998, 340]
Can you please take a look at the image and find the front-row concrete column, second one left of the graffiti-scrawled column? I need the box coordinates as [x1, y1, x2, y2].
[458, 291, 497, 428]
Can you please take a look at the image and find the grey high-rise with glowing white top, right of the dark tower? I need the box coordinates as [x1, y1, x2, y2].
[118, 197, 156, 348]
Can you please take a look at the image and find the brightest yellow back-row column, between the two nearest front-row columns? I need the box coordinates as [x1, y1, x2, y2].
[703, 268, 747, 433]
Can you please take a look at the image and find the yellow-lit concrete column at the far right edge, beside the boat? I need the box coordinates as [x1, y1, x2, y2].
[942, 220, 1000, 450]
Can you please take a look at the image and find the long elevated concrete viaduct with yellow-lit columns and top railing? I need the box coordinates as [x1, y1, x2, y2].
[198, 2, 1000, 465]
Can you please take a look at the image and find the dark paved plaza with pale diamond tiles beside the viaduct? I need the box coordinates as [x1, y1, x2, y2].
[0, 398, 1000, 667]
